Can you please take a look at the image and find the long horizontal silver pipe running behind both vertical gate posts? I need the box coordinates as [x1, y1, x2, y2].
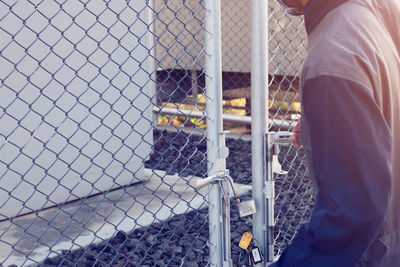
[153, 106, 297, 130]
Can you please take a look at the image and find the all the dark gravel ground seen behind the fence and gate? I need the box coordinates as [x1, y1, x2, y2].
[42, 131, 313, 267]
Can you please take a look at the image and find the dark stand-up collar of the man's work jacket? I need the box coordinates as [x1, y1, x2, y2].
[304, 0, 348, 35]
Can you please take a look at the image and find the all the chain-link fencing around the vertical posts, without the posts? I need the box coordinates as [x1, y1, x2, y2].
[0, 0, 313, 266]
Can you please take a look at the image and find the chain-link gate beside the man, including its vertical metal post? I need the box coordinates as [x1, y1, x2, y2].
[247, 1, 313, 266]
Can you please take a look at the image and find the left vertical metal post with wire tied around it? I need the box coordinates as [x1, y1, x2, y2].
[204, 0, 227, 267]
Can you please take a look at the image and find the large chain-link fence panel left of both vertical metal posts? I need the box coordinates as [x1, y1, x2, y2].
[0, 0, 212, 266]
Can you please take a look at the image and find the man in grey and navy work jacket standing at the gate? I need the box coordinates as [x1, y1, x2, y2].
[271, 0, 400, 267]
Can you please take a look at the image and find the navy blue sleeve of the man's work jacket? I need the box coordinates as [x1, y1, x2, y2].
[271, 76, 392, 267]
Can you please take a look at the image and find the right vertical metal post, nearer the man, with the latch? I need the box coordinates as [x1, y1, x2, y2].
[251, 0, 268, 266]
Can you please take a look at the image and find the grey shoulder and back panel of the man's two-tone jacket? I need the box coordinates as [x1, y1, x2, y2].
[302, 0, 400, 266]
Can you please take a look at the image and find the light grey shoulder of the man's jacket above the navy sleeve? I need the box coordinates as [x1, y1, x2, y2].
[302, 1, 379, 87]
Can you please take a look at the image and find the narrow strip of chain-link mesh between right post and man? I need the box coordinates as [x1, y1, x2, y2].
[268, 1, 314, 255]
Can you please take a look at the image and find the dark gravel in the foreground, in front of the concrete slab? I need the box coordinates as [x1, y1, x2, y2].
[43, 202, 251, 267]
